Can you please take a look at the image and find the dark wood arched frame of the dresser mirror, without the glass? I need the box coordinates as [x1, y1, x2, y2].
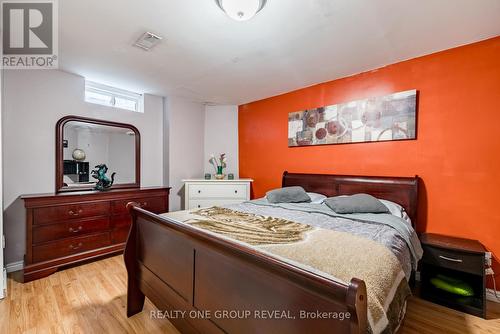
[56, 115, 141, 193]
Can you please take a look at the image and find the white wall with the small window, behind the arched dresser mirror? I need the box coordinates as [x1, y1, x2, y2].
[2, 70, 163, 263]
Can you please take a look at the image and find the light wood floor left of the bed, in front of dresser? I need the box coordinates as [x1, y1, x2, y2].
[0, 256, 179, 334]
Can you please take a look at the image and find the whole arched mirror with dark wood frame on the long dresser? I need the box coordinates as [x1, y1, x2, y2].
[56, 116, 141, 192]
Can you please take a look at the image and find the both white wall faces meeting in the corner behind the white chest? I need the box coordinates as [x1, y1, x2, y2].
[163, 102, 238, 211]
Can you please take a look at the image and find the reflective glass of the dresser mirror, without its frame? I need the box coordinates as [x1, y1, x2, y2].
[62, 121, 136, 189]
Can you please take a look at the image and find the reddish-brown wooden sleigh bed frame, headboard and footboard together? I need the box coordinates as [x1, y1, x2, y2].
[124, 172, 418, 334]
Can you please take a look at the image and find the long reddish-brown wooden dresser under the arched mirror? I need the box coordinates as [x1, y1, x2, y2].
[21, 187, 170, 282]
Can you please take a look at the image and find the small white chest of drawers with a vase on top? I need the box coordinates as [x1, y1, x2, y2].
[182, 179, 253, 210]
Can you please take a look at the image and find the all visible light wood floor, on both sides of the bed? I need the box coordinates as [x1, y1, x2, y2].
[0, 256, 500, 334]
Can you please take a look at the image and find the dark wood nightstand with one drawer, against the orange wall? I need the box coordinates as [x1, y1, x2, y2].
[420, 233, 486, 318]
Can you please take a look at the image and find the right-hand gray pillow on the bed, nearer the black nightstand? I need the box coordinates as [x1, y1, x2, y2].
[324, 194, 389, 214]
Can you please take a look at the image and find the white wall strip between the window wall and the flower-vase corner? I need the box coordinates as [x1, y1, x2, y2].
[164, 96, 205, 211]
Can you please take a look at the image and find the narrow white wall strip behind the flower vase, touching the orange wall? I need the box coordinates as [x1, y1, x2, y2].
[204, 105, 239, 178]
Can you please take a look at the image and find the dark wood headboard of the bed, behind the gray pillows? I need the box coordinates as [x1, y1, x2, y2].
[282, 172, 419, 227]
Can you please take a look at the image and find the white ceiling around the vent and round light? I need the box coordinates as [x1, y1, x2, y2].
[59, 0, 500, 104]
